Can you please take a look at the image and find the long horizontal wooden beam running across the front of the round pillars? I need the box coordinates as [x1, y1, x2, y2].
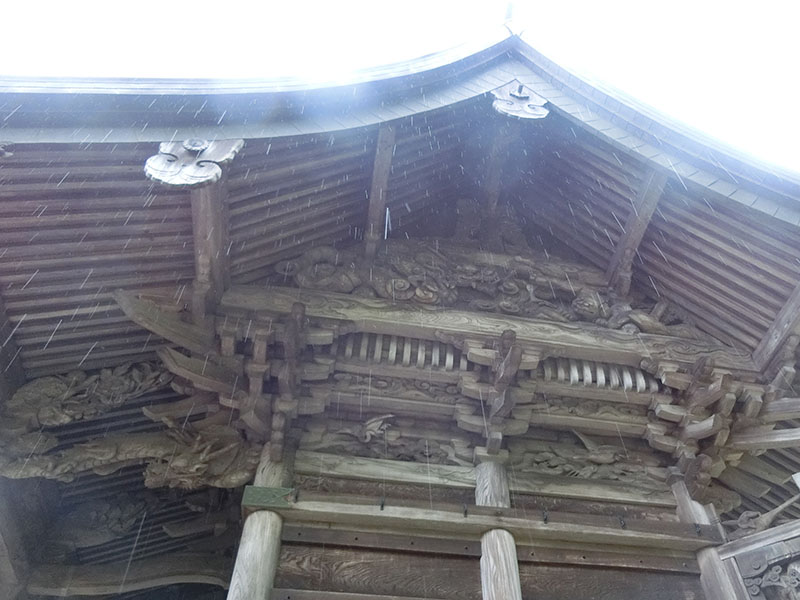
[245, 494, 722, 551]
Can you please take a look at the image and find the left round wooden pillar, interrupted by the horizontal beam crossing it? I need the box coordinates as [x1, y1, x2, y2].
[228, 443, 294, 600]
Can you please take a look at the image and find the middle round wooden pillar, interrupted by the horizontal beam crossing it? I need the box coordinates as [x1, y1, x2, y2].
[475, 451, 522, 600]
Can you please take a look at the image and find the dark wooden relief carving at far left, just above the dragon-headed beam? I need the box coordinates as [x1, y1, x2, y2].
[0, 362, 172, 456]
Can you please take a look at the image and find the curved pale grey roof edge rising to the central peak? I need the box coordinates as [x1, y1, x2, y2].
[0, 32, 800, 220]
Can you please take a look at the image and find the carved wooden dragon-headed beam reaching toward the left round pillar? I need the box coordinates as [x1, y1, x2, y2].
[0, 413, 260, 489]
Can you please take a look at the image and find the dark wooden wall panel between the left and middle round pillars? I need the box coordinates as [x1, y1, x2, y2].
[276, 544, 481, 600]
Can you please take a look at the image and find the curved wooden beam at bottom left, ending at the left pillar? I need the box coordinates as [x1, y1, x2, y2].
[28, 553, 230, 597]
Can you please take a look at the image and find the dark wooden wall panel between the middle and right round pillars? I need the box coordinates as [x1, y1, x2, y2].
[520, 564, 704, 600]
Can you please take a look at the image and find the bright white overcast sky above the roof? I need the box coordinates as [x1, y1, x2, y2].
[0, 0, 800, 172]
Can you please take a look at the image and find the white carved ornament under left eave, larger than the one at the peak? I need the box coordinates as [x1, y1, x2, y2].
[144, 138, 244, 187]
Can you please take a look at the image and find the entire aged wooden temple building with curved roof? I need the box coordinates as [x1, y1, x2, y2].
[0, 30, 800, 600]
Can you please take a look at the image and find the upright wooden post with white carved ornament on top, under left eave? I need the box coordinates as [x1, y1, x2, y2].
[144, 139, 244, 325]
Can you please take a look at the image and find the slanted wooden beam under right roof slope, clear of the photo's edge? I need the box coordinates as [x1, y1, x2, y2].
[606, 170, 667, 295]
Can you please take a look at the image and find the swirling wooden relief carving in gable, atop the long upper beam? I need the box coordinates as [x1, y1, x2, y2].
[275, 241, 711, 341]
